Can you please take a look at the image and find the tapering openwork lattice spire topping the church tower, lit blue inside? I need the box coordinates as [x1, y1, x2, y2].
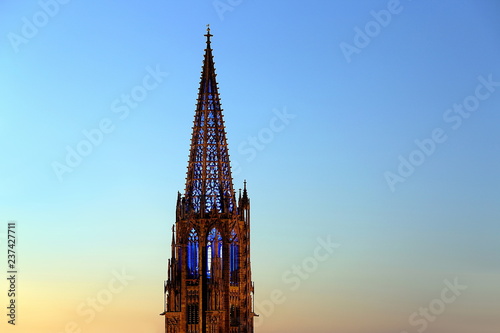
[185, 31, 235, 213]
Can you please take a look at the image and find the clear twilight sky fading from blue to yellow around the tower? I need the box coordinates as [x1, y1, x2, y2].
[0, 0, 500, 333]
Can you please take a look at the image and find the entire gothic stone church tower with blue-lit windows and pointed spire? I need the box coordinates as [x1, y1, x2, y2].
[162, 28, 254, 333]
